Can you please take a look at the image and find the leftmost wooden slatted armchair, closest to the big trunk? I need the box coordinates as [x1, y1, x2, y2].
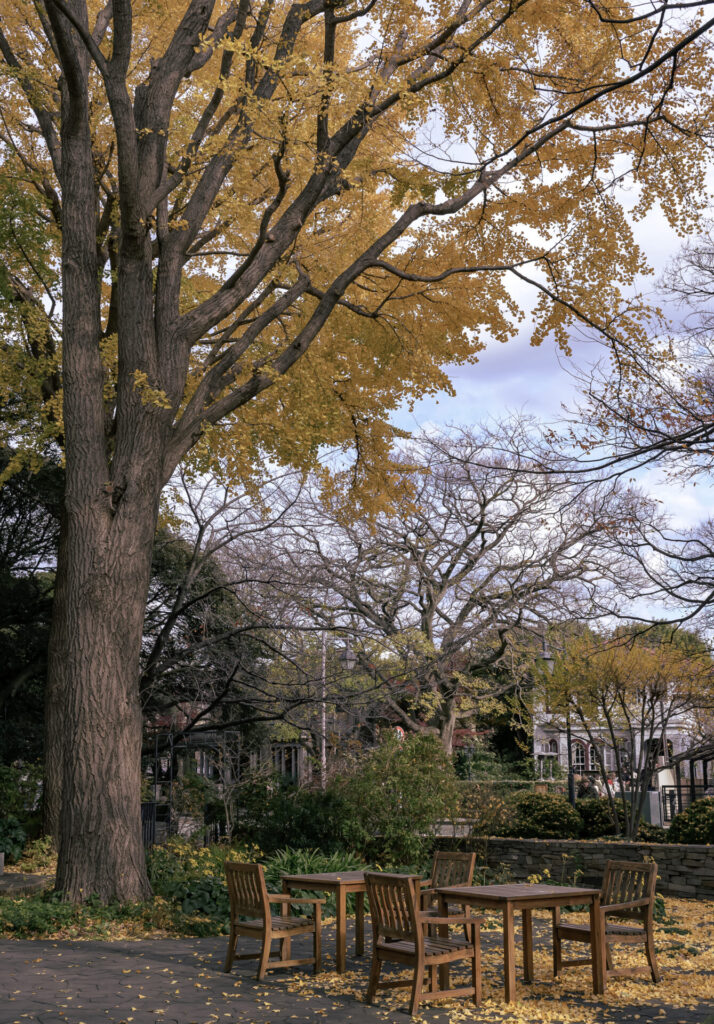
[224, 860, 325, 981]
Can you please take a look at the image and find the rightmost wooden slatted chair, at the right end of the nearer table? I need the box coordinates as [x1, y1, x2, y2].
[553, 860, 660, 982]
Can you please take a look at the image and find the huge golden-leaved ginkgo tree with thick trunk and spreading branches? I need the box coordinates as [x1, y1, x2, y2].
[0, 0, 714, 899]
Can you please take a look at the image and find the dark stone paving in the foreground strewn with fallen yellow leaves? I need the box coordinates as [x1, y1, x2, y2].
[0, 928, 714, 1024]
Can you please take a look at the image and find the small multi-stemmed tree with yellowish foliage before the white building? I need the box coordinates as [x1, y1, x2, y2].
[533, 624, 714, 839]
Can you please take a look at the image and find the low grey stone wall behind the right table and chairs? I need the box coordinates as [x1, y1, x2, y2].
[439, 838, 714, 900]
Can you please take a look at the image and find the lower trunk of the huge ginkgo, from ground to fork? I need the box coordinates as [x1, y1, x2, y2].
[53, 477, 156, 900]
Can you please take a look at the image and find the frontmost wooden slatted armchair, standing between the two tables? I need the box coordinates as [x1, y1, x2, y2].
[365, 871, 482, 1014]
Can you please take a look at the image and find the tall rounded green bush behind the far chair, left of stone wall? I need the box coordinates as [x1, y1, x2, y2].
[340, 735, 459, 866]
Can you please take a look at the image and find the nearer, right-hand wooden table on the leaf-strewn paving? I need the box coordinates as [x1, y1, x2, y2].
[436, 883, 604, 1002]
